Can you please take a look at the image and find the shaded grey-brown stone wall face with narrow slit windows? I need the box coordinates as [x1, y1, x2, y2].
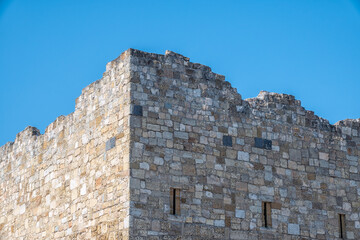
[130, 51, 360, 239]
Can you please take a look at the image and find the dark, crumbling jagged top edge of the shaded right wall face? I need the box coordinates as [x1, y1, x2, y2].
[128, 49, 360, 137]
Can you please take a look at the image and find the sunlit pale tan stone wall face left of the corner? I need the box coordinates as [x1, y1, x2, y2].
[0, 52, 134, 240]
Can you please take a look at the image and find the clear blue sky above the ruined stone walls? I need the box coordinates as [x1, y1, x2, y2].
[0, 0, 360, 145]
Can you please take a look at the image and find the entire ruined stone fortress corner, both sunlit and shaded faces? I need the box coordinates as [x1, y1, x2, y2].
[0, 49, 360, 240]
